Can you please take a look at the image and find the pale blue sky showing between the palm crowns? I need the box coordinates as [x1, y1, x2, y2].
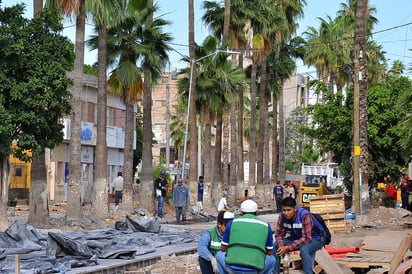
[0, 0, 412, 75]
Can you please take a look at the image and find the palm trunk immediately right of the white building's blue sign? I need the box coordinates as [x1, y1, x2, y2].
[92, 27, 109, 218]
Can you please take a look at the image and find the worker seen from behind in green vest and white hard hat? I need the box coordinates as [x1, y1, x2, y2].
[216, 199, 275, 274]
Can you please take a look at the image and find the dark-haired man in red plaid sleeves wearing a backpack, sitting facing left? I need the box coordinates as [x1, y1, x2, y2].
[274, 197, 326, 274]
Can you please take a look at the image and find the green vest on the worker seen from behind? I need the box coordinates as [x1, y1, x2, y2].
[226, 214, 268, 270]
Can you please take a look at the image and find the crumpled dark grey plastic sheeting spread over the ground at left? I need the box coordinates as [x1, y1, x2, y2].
[0, 216, 200, 274]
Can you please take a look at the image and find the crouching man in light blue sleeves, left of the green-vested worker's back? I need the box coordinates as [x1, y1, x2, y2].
[197, 211, 235, 274]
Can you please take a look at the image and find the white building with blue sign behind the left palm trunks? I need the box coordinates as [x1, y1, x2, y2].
[46, 75, 137, 202]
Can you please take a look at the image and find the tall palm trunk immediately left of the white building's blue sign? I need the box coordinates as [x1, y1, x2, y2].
[66, 0, 86, 219]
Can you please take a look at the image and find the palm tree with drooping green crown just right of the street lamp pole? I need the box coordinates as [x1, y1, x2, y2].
[179, 36, 244, 207]
